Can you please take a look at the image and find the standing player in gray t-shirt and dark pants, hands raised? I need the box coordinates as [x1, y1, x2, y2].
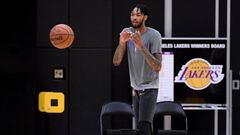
[113, 4, 162, 135]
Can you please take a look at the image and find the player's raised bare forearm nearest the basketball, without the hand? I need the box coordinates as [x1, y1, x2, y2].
[113, 41, 126, 66]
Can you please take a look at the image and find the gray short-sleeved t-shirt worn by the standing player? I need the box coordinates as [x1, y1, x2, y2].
[127, 27, 162, 90]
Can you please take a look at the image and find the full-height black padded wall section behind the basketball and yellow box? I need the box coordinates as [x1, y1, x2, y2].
[37, 0, 112, 135]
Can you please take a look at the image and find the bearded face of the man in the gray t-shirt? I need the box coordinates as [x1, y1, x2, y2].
[130, 8, 146, 28]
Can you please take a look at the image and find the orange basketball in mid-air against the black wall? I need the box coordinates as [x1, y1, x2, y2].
[49, 24, 74, 49]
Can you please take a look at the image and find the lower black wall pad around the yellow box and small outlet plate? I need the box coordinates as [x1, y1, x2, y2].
[36, 48, 69, 135]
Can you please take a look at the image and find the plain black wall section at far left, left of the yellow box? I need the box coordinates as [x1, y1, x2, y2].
[0, 0, 37, 135]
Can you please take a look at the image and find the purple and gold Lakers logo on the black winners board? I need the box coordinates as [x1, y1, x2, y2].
[175, 58, 224, 90]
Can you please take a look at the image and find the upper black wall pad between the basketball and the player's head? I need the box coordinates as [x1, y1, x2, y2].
[69, 0, 112, 49]
